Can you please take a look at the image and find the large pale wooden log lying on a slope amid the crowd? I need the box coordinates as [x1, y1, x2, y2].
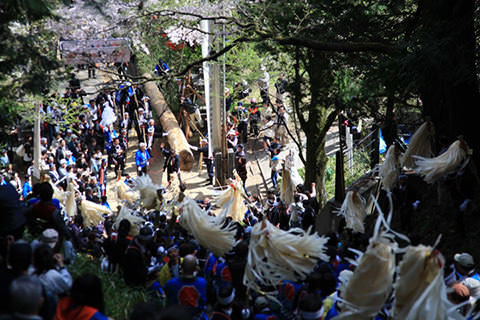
[143, 73, 194, 171]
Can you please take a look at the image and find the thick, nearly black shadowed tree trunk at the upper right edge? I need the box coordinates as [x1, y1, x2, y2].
[418, 0, 480, 167]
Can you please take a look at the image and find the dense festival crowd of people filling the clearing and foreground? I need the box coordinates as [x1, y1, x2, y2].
[0, 63, 480, 320]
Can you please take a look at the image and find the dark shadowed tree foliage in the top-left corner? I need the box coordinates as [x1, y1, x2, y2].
[0, 0, 59, 97]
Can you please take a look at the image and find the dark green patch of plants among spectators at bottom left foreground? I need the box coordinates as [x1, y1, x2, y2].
[68, 254, 148, 320]
